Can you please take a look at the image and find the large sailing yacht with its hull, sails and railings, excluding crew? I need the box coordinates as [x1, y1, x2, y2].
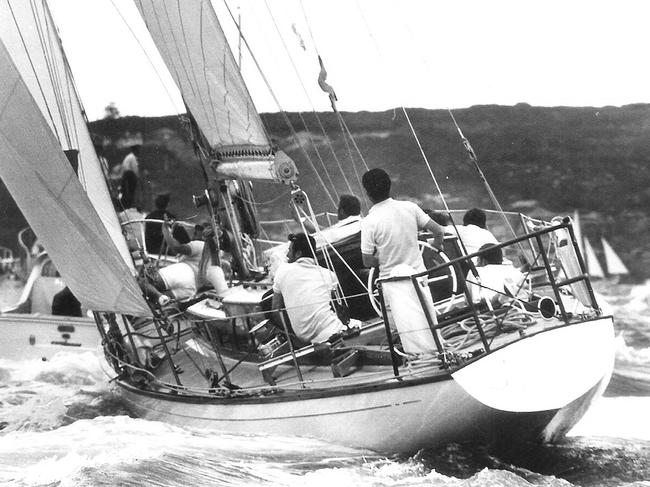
[0, 0, 614, 453]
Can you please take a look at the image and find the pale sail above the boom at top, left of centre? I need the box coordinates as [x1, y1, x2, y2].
[134, 0, 271, 155]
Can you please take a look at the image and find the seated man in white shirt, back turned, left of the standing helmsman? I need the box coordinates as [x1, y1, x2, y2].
[272, 233, 345, 343]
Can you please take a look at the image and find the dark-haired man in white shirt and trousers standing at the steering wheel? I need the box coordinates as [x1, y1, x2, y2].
[361, 169, 444, 355]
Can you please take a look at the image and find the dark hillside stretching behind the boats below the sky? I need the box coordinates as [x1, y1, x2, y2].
[0, 104, 650, 278]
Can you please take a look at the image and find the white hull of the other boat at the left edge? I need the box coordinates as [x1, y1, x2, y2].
[0, 313, 101, 360]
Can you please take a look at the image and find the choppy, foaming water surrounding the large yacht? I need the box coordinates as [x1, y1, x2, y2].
[0, 283, 650, 487]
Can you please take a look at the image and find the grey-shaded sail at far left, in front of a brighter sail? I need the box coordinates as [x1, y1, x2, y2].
[0, 42, 151, 316]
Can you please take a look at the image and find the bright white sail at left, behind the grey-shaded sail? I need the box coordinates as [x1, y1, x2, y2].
[0, 0, 134, 271]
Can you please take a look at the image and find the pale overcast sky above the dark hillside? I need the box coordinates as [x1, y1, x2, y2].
[50, 0, 650, 120]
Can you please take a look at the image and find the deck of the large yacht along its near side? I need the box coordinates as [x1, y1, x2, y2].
[129, 306, 580, 394]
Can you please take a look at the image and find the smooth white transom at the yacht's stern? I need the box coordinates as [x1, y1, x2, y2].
[452, 316, 615, 419]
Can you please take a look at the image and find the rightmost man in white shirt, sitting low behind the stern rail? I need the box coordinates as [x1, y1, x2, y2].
[466, 244, 528, 306]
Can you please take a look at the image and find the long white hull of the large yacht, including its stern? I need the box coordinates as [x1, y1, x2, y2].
[107, 317, 614, 452]
